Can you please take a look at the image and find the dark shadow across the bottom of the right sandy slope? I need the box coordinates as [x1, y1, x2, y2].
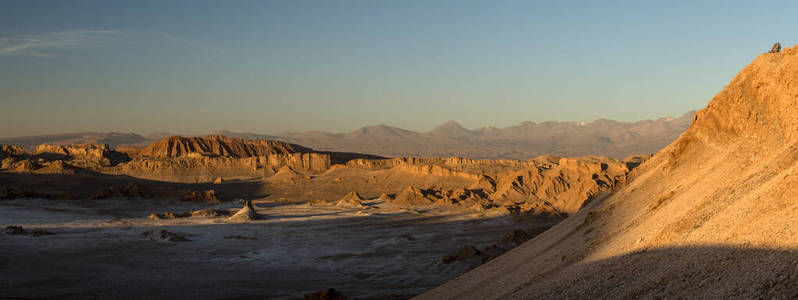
[497, 245, 798, 299]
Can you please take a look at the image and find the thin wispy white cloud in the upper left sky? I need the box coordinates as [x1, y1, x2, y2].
[0, 30, 120, 57]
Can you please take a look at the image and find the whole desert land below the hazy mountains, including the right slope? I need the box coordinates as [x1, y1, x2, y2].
[0, 44, 798, 299]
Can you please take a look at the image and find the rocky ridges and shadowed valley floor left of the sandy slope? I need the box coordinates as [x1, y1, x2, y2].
[0, 116, 664, 299]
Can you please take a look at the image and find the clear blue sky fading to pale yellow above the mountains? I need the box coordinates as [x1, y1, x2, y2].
[0, 0, 798, 137]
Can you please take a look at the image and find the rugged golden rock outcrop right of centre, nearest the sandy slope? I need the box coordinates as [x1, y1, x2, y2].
[362, 156, 638, 217]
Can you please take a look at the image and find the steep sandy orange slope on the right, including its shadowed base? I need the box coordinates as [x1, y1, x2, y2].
[419, 47, 798, 299]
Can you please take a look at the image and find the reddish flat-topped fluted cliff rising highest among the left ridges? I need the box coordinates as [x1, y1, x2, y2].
[138, 135, 312, 158]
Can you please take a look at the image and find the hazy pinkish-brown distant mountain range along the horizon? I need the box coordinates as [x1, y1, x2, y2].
[0, 111, 695, 159]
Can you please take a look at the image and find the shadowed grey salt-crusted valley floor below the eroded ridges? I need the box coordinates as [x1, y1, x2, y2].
[0, 199, 552, 299]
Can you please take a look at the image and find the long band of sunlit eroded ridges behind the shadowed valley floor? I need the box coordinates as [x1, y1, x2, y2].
[0, 136, 642, 217]
